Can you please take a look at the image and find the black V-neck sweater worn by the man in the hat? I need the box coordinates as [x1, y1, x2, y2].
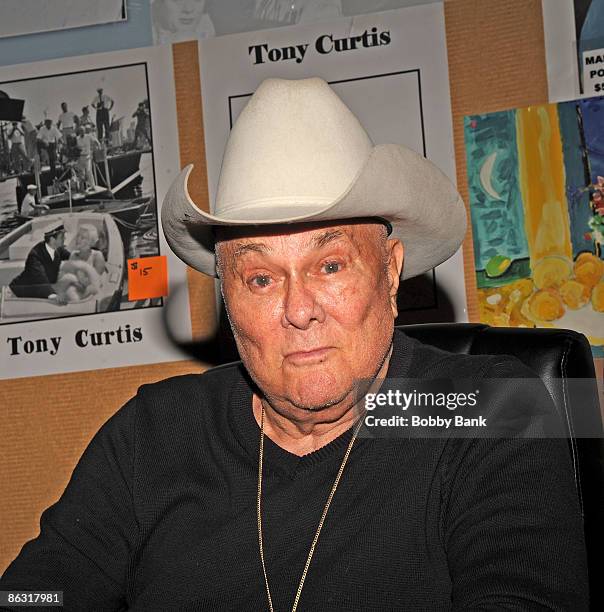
[0, 332, 587, 612]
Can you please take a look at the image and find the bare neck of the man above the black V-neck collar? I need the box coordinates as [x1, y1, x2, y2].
[252, 347, 392, 457]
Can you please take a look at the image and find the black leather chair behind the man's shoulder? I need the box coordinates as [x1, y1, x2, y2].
[399, 323, 604, 611]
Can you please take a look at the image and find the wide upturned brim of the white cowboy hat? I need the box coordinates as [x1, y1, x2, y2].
[161, 144, 466, 279]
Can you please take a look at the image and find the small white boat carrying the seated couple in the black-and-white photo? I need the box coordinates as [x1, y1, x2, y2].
[0, 211, 125, 324]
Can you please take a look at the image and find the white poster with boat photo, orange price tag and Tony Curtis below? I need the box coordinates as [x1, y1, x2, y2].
[0, 47, 191, 378]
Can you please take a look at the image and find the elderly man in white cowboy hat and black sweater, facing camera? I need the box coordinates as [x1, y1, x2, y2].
[0, 79, 587, 611]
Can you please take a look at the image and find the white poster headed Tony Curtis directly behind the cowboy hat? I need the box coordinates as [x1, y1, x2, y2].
[199, 3, 467, 323]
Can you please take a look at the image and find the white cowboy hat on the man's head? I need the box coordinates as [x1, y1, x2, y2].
[162, 78, 466, 278]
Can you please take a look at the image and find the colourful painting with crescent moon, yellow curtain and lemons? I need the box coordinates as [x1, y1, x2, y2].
[464, 98, 604, 357]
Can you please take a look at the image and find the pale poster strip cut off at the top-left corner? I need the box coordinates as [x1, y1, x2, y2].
[0, 0, 126, 37]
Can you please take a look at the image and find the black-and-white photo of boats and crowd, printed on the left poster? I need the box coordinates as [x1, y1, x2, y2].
[0, 63, 161, 324]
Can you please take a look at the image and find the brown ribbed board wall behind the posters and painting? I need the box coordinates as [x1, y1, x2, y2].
[0, 0, 602, 573]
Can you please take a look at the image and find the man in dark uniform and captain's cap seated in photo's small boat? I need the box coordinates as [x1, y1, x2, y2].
[9, 223, 70, 303]
